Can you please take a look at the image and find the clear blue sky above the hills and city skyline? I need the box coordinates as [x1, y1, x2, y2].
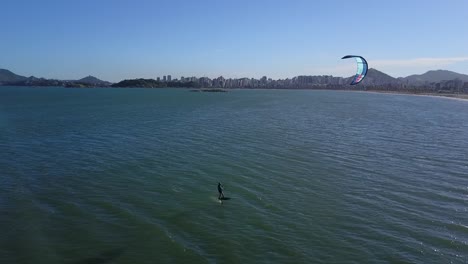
[0, 0, 468, 81]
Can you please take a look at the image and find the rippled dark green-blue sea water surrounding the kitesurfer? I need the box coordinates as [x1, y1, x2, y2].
[0, 87, 468, 264]
